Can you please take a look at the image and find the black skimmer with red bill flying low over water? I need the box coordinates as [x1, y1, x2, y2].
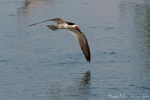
[29, 18, 91, 63]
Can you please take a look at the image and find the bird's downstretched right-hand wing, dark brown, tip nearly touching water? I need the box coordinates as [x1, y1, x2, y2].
[68, 29, 91, 62]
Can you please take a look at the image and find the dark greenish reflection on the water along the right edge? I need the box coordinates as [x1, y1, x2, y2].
[134, 0, 150, 90]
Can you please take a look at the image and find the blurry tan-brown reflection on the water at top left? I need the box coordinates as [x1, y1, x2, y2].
[17, 0, 56, 28]
